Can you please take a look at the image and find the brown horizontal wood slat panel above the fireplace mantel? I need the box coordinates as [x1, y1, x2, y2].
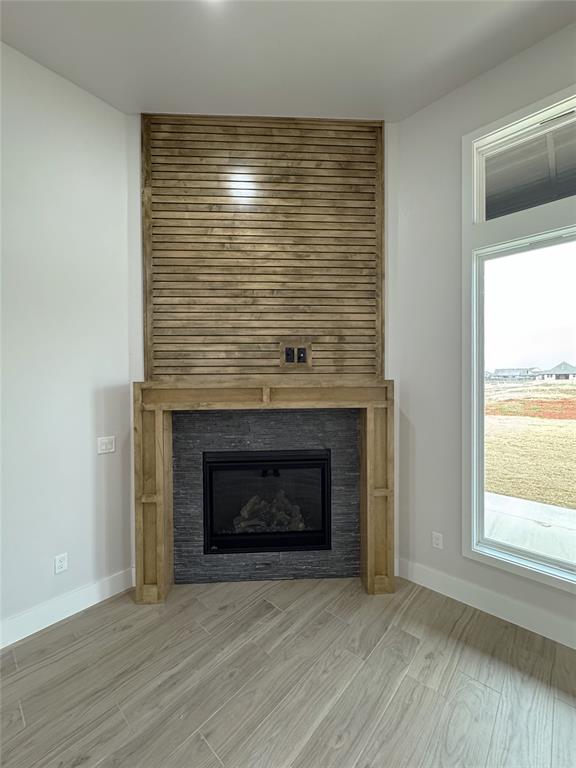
[142, 115, 383, 380]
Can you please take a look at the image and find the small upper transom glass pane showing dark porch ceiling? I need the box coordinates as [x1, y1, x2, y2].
[485, 122, 576, 219]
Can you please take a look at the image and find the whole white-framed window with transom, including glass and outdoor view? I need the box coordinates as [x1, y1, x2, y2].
[463, 88, 576, 589]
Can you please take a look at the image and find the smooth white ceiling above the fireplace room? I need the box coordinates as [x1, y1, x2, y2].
[2, 0, 576, 120]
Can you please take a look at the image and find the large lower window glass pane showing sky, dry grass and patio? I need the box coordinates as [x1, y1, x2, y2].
[482, 242, 576, 566]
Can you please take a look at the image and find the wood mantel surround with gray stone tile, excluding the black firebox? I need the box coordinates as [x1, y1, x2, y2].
[134, 384, 394, 603]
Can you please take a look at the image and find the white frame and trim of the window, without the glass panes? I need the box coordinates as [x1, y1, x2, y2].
[462, 88, 576, 594]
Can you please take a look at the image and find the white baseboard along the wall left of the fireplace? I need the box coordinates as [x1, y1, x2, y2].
[0, 568, 134, 648]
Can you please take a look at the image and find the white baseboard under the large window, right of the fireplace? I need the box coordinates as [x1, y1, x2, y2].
[398, 558, 576, 648]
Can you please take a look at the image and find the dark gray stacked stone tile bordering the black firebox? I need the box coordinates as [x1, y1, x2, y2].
[173, 409, 360, 584]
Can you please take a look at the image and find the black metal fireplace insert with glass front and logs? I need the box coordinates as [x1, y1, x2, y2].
[203, 450, 331, 554]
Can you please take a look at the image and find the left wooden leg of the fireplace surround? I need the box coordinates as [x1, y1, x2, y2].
[134, 385, 173, 603]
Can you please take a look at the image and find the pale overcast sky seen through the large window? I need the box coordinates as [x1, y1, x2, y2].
[484, 241, 576, 371]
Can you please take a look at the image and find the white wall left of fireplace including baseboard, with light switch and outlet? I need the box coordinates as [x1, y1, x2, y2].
[2, 46, 133, 643]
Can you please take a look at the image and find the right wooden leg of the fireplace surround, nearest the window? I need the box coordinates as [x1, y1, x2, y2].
[360, 404, 394, 595]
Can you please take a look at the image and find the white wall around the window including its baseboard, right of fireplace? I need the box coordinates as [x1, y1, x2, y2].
[386, 26, 576, 643]
